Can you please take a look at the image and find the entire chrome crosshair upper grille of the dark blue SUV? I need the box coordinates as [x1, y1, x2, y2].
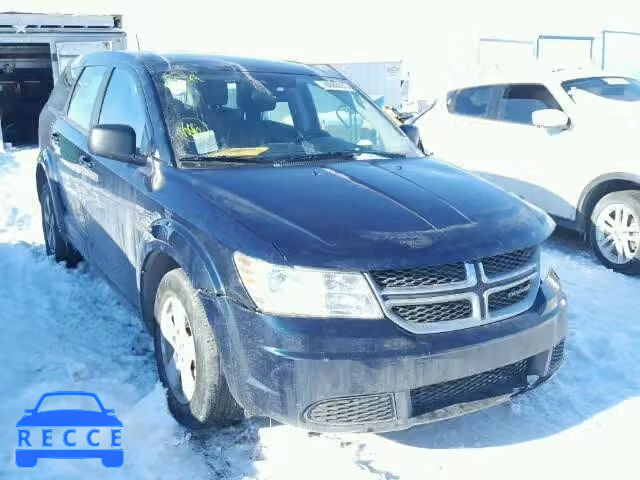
[367, 247, 540, 333]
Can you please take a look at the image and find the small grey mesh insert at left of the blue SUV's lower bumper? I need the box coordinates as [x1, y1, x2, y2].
[304, 393, 396, 425]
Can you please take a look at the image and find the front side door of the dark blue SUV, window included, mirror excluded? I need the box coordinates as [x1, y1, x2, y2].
[86, 66, 151, 303]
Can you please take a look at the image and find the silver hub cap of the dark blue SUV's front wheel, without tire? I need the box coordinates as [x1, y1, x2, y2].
[158, 294, 196, 404]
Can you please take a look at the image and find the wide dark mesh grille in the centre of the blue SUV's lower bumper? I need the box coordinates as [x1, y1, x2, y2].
[411, 359, 529, 416]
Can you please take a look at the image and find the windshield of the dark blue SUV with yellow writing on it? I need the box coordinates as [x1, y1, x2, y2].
[155, 67, 421, 163]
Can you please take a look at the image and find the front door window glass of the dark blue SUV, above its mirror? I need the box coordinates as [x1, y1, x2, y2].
[98, 68, 148, 150]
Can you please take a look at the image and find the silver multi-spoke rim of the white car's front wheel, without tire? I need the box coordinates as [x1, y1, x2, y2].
[596, 203, 640, 265]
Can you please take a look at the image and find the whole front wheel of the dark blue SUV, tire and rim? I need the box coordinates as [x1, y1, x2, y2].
[154, 268, 243, 430]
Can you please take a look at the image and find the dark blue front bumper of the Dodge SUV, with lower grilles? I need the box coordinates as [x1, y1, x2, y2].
[204, 272, 567, 432]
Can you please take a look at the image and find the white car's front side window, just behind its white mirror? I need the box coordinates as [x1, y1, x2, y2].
[498, 84, 561, 125]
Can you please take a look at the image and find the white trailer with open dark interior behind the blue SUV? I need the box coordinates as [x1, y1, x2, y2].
[0, 13, 126, 148]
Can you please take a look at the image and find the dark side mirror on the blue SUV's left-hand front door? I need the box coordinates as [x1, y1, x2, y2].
[89, 124, 146, 165]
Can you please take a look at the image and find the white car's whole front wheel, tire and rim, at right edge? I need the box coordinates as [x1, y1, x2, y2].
[589, 190, 640, 275]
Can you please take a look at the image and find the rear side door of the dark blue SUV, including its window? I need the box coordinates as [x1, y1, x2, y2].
[50, 66, 107, 255]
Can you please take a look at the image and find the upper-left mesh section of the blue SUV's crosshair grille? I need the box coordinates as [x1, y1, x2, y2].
[371, 262, 467, 288]
